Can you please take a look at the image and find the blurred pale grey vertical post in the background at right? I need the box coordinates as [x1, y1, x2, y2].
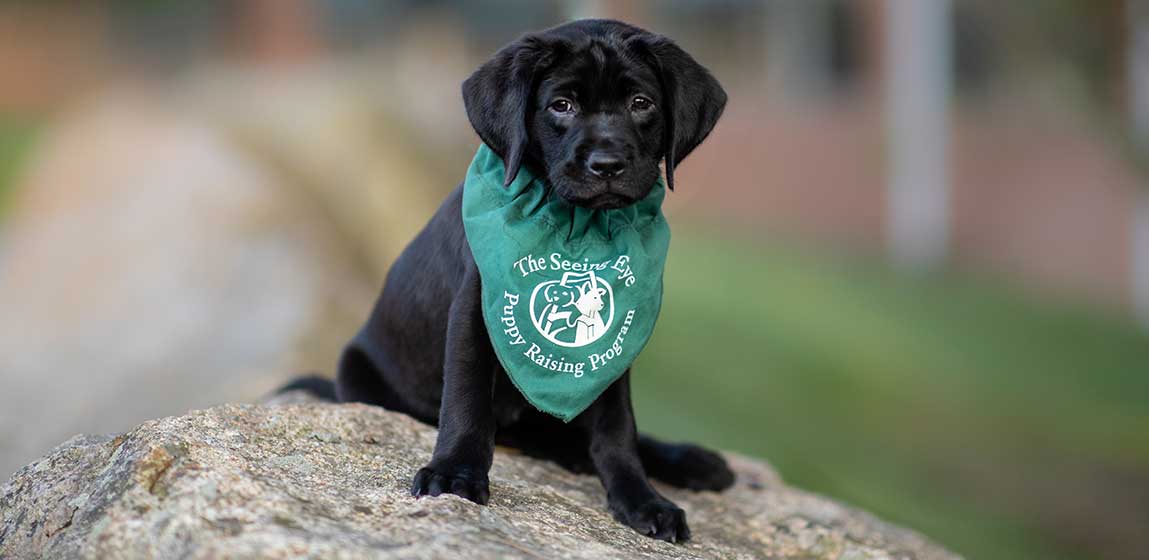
[885, 0, 953, 268]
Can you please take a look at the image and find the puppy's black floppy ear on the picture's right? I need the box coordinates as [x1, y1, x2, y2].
[634, 34, 726, 190]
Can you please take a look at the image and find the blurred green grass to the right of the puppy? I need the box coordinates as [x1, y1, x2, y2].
[633, 230, 1149, 559]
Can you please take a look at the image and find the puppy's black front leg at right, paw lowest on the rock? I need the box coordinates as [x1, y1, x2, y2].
[579, 370, 691, 543]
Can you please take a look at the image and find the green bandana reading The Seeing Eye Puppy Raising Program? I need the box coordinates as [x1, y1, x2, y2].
[463, 145, 670, 422]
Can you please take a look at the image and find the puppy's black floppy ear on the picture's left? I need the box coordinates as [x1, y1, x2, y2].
[463, 34, 553, 185]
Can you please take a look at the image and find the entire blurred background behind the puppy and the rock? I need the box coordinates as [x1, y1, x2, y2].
[0, 0, 1149, 559]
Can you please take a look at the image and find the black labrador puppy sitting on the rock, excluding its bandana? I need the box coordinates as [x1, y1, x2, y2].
[291, 20, 734, 542]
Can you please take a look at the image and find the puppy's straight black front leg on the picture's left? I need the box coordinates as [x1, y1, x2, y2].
[411, 263, 495, 504]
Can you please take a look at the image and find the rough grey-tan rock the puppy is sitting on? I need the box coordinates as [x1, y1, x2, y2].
[0, 402, 955, 560]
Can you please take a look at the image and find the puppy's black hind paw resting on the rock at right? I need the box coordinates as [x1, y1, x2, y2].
[639, 434, 734, 491]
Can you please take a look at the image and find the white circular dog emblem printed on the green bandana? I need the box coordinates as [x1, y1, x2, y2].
[531, 270, 615, 348]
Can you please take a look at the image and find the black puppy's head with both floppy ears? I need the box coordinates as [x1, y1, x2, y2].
[463, 20, 726, 208]
